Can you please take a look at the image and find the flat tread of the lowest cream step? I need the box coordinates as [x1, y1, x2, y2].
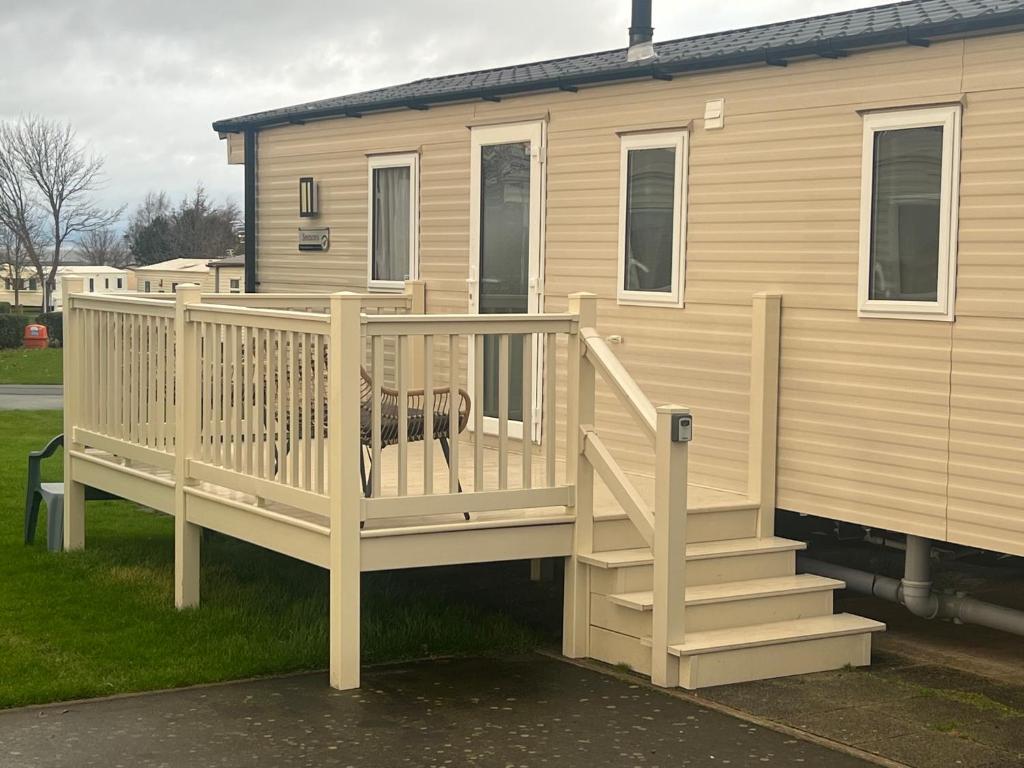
[669, 613, 886, 656]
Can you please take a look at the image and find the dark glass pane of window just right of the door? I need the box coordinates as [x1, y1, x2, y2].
[623, 147, 678, 293]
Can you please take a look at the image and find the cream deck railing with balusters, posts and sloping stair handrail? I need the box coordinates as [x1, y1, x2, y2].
[65, 281, 765, 687]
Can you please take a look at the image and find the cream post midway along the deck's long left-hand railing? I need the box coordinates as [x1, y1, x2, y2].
[174, 284, 202, 608]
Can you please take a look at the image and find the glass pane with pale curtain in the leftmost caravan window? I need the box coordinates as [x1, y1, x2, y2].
[373, 166, 412, 281]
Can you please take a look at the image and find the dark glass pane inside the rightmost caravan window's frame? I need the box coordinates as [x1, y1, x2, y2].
[869, 126, 942, 301]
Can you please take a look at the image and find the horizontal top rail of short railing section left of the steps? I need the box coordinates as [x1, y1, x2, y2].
[362, 314, 579, 336]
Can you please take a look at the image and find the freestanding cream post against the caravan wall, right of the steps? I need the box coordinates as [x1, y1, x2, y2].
[746, 293, 782, 538]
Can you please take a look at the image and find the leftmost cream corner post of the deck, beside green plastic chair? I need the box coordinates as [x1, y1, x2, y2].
[61, 278, 92, 551]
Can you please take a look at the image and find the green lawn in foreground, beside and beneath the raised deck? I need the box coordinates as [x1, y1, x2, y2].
[0, 412, 558, 708]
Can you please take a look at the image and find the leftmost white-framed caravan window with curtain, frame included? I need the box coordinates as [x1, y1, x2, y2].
[367, 153, 420, 290]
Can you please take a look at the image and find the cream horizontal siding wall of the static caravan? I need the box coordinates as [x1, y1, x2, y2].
[245, 33, 1024, 553]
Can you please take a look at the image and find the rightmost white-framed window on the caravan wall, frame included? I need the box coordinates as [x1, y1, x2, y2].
[858, 104, 961, 321]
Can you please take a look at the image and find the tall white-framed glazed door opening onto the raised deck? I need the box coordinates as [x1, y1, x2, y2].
[469, 123, 544, 440]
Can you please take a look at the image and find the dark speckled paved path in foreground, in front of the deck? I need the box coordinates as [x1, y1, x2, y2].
[0, 656, 868, 768]
